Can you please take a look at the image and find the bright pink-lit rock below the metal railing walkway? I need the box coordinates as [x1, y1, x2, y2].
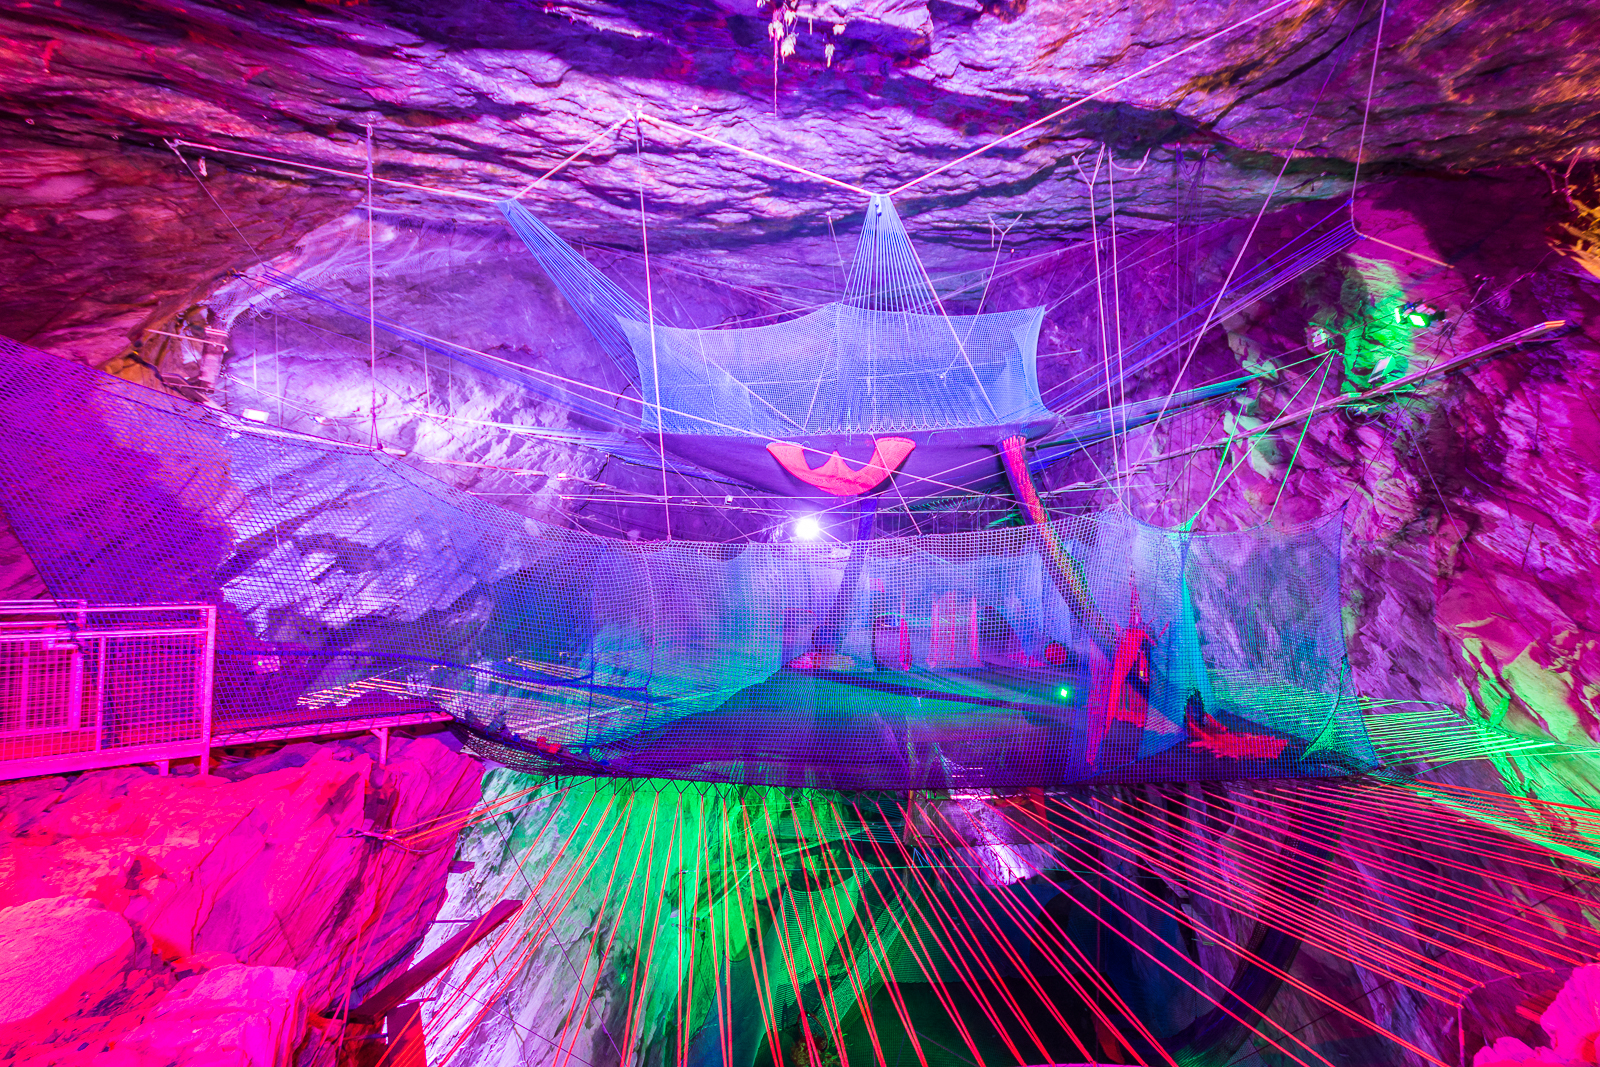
[0, 734, 480, 1067]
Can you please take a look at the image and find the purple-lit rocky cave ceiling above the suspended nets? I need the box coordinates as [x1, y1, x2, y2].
[0, 0, 1600, 362]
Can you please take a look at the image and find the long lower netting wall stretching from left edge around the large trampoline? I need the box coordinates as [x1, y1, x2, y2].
[0, 342, 1373, 789]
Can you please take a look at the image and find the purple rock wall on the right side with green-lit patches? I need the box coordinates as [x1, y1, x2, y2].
[1100, 171, 1600, 771]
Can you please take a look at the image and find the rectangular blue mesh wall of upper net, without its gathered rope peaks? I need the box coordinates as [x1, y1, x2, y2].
[622, 304, 1054, 440]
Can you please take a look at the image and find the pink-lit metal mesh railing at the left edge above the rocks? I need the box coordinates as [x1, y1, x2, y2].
[0, 600, 216, 781]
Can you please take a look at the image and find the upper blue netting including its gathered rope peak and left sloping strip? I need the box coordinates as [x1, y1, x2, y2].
[502, 197, 1054, 440]
